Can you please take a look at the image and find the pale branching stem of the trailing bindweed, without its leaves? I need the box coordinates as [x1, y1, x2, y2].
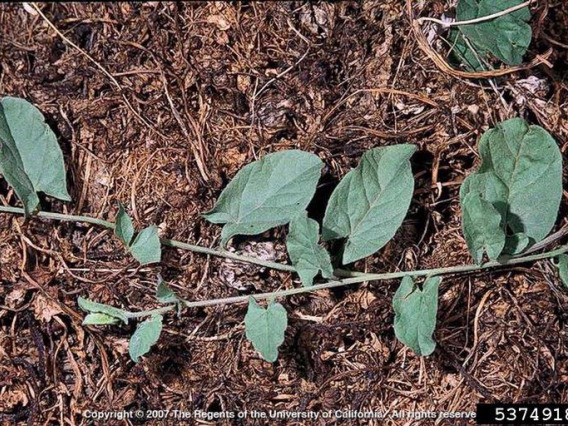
[0, 206, 568, 318]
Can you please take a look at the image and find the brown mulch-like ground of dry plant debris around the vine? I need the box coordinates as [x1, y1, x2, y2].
[0, 0, 568, 425]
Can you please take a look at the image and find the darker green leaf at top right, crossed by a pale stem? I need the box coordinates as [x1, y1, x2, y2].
[456, 0, 532, 65]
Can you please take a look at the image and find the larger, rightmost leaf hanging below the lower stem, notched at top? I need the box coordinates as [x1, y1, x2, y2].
[393, 276, 442, 356]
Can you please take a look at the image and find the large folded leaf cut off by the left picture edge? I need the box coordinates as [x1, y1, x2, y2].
[0, 97, 71, 214]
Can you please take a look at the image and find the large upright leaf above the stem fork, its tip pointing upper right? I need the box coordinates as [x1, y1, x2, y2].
[323, 145, 416, 264]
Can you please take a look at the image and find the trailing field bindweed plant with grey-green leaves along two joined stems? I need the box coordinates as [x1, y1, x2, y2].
[0, 97, 568, 362]
